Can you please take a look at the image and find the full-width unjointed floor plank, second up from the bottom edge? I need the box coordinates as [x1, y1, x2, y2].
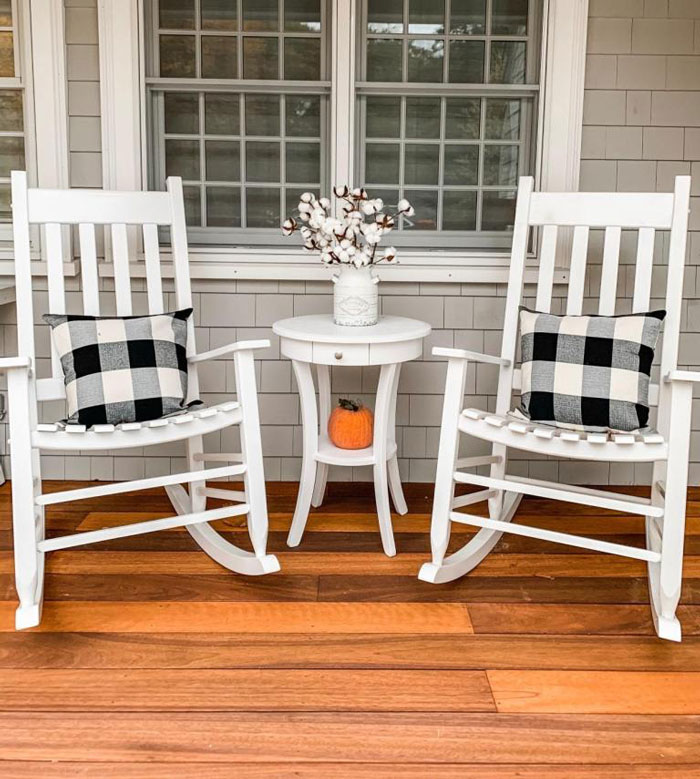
[0, 712, 700, 773]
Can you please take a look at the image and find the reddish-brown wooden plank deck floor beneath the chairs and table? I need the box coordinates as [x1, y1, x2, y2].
[0, 483, 700, 779]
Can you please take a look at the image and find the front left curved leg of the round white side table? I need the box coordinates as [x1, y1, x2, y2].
[287, 360, 318, 546]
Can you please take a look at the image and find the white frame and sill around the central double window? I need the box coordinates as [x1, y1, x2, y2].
[98, 0, 588, 283]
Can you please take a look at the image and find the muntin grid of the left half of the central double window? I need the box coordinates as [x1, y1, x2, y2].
[146, 0, 330, 243]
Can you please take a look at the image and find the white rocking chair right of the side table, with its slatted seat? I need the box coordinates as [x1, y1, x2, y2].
[419, 176, 700, 641]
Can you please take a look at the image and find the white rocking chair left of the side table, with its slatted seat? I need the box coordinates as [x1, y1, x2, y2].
[6, 172, 279, 629]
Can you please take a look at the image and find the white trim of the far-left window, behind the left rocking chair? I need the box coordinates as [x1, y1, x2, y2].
[0, 0, 75, 276]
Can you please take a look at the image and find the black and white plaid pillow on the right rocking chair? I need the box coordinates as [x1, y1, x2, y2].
[520, 309, 666, 431]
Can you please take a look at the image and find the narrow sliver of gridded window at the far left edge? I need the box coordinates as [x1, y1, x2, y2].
[0, 0, 26, 223]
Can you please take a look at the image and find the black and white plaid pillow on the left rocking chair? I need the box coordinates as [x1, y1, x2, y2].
[44, 308, 192, 426]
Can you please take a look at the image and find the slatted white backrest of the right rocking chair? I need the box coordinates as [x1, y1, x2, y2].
[496, 176, 690, 426]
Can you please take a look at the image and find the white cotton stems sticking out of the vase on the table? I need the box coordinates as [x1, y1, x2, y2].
[282, 187, 415, 268]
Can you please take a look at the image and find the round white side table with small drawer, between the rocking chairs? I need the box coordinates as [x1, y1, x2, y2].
[272, 314, 430, 557]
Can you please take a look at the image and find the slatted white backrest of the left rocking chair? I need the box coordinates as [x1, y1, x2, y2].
[12, 171, 199, 400]
